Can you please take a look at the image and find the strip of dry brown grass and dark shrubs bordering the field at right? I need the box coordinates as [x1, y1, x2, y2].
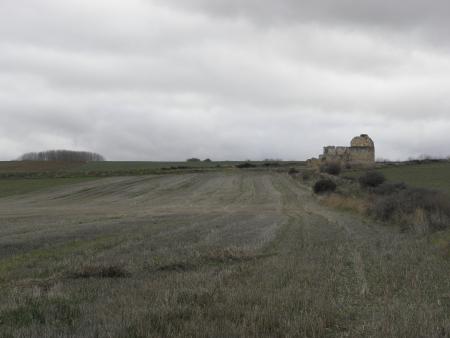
[318, 172, 450, 234]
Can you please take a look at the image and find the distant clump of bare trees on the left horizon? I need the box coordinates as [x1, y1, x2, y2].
[19, 150, 105, 162]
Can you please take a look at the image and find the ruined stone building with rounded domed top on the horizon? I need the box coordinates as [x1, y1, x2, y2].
[308, 134, 375, 166]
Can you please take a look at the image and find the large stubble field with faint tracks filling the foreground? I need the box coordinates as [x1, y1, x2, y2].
[0, 164, 450, 337]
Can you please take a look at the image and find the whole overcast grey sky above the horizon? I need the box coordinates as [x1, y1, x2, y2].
[0, 0, 450, 160]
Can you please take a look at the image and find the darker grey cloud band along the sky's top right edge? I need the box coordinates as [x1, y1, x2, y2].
[164, 0, 450, 30]
